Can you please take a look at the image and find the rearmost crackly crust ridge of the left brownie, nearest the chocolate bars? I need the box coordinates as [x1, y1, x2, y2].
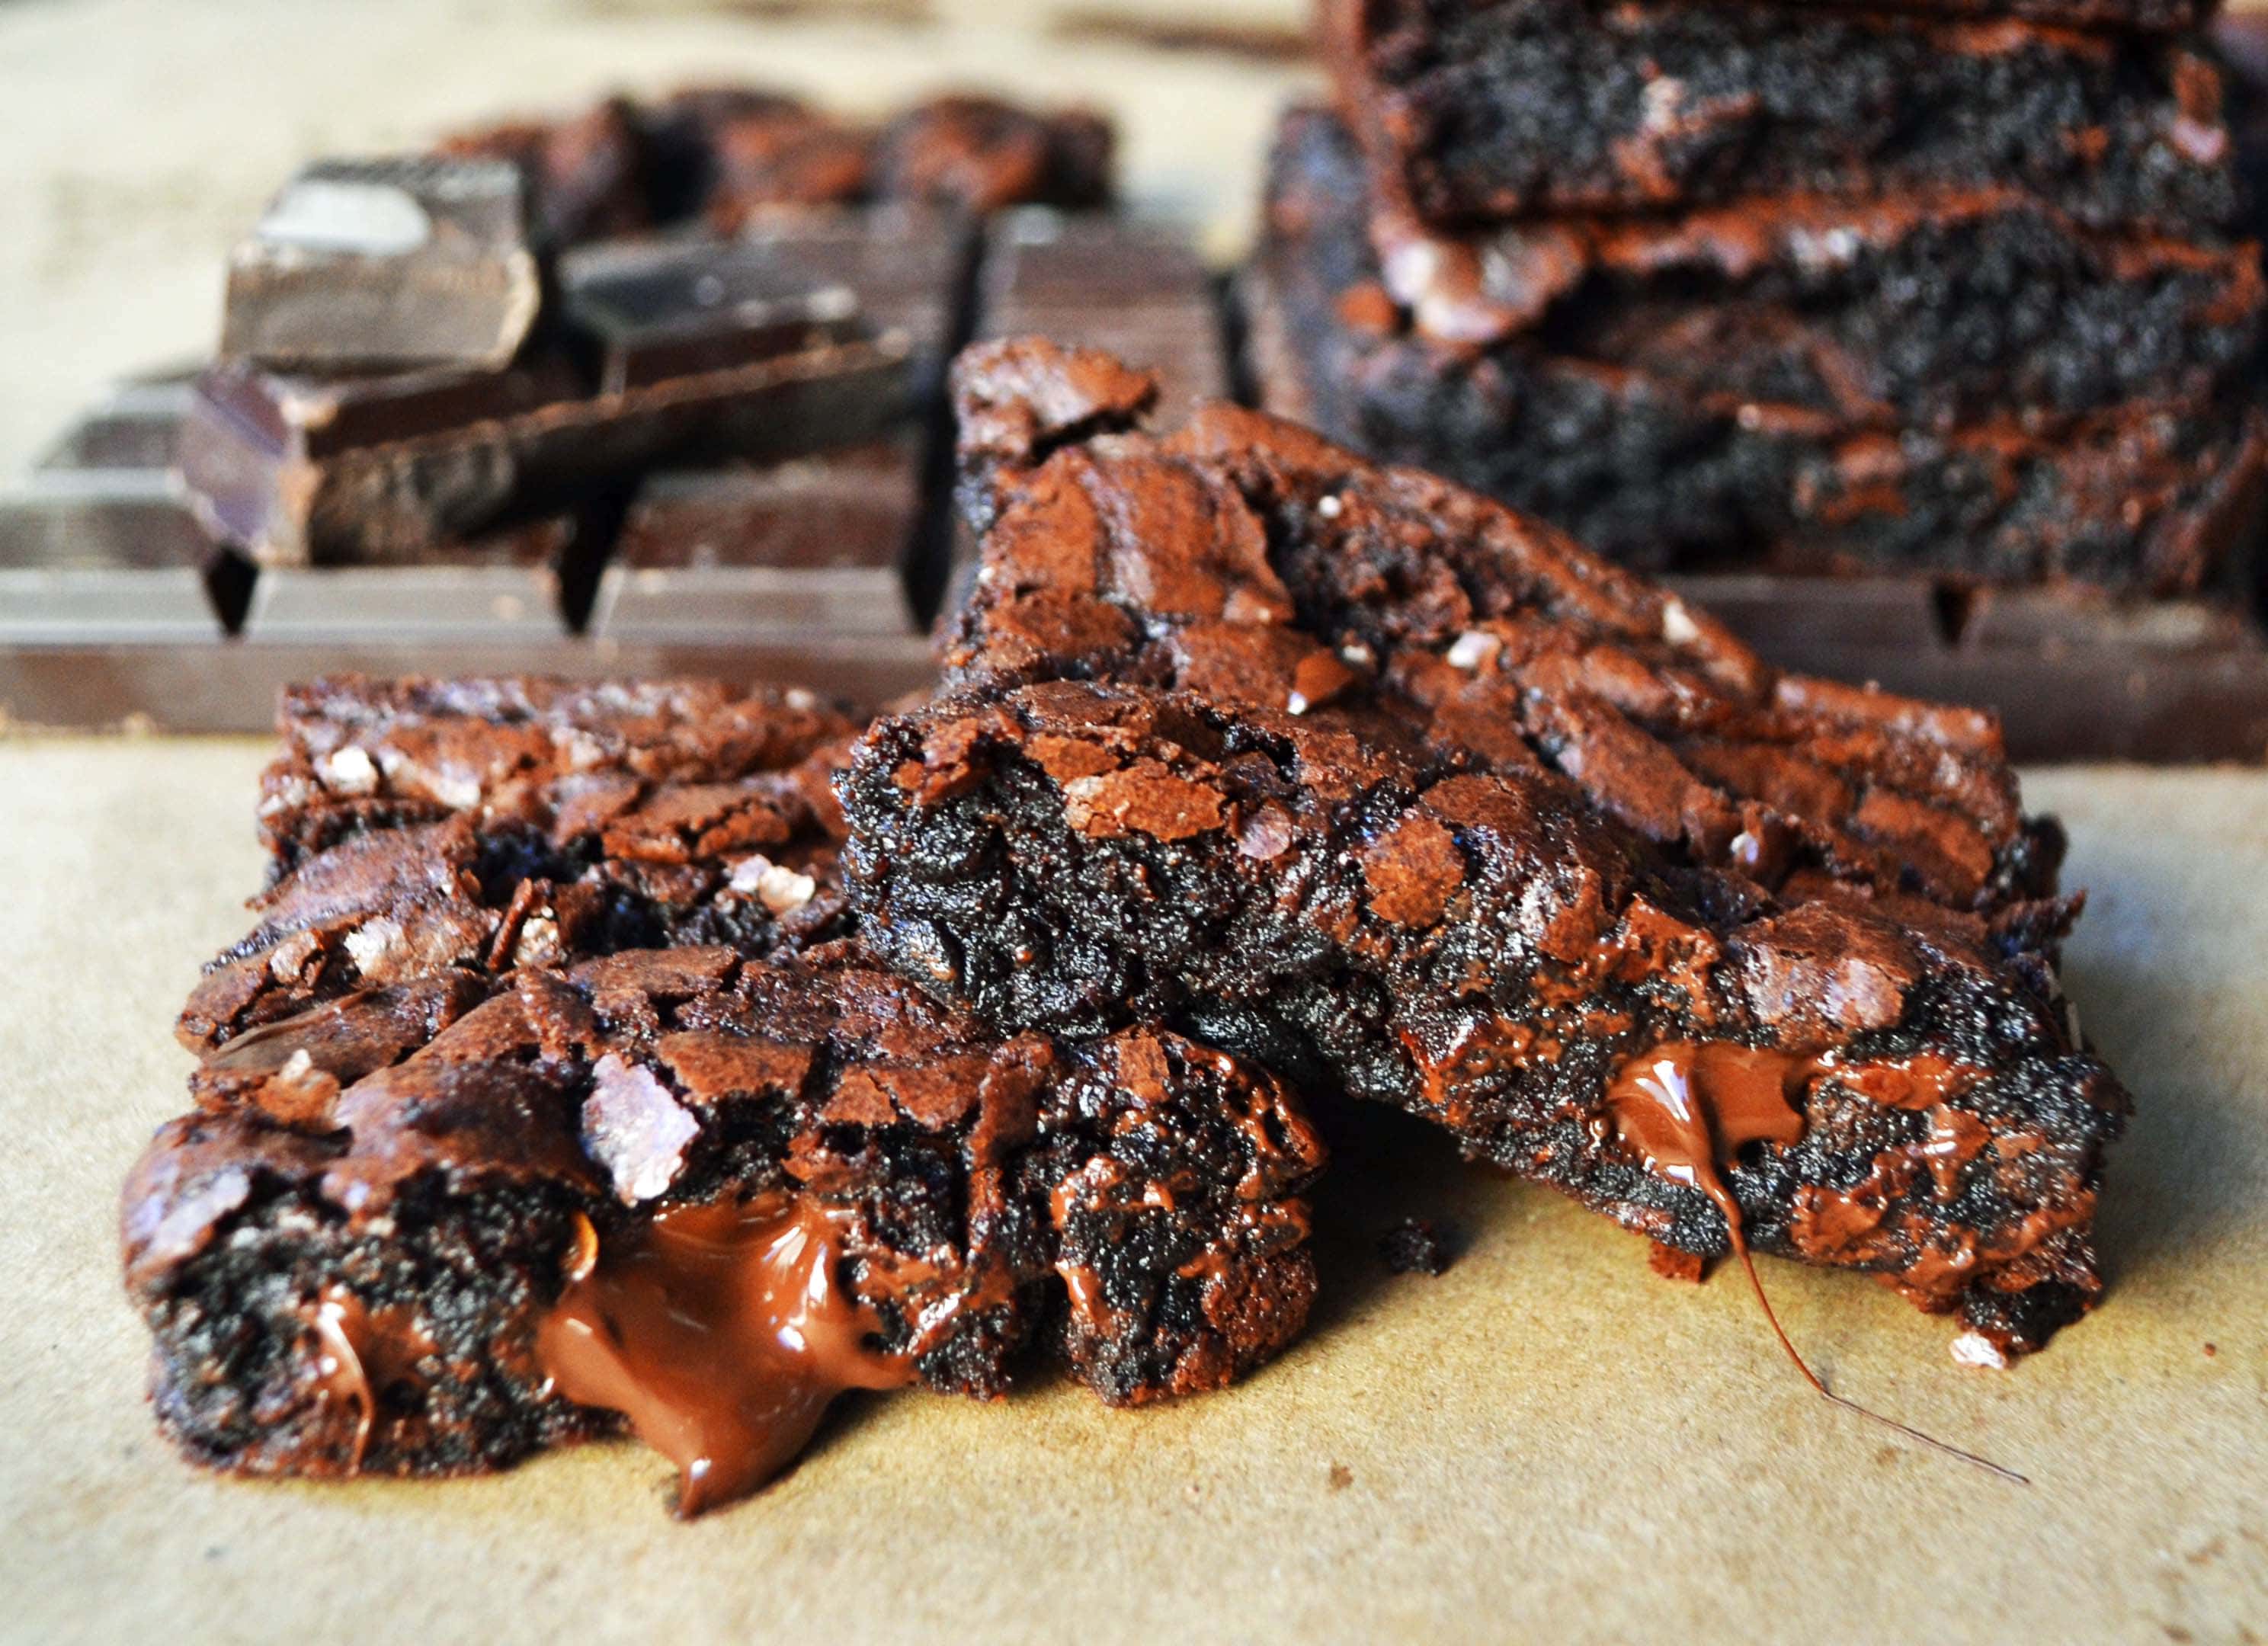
[261, 676, 857, 869]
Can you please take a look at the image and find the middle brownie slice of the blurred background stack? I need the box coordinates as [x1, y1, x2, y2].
[1347, 181, 2261, 431]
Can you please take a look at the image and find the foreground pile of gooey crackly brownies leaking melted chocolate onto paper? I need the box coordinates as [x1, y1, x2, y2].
[125, 340, 2127, 1512]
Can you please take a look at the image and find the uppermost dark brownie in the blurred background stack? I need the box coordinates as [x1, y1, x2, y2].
[1325, 0, 2238, 235]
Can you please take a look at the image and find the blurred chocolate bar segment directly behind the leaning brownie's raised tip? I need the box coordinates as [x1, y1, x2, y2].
[978, 207, 1229, 411]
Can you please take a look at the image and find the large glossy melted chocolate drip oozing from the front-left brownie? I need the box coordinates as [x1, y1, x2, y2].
[535, 1197, 914, 1516]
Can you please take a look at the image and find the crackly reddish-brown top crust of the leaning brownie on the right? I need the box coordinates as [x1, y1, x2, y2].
[946, 342, 2059, 925]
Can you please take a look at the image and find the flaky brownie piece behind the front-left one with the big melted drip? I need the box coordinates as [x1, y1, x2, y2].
[179, 678, 853, 1052]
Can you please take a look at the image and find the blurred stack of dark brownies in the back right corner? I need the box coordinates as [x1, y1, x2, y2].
[1250, 0, 2263, 594]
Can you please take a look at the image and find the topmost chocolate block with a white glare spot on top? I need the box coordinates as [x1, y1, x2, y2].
[220, 159, 542, 372]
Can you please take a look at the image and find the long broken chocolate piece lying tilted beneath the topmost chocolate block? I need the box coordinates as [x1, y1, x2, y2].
[181, 338, 905, 565]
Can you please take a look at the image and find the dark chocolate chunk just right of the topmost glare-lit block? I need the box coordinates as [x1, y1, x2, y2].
[558, 240, 860, 395]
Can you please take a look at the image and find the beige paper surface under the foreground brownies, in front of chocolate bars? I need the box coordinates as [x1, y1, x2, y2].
[0, 741, 2268, 1644]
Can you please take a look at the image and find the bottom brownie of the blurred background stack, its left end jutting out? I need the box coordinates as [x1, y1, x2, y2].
[1243, 111, 2263, 594]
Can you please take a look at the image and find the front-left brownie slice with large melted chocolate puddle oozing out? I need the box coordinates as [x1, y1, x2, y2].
[123, 948, 1322, 1512]
